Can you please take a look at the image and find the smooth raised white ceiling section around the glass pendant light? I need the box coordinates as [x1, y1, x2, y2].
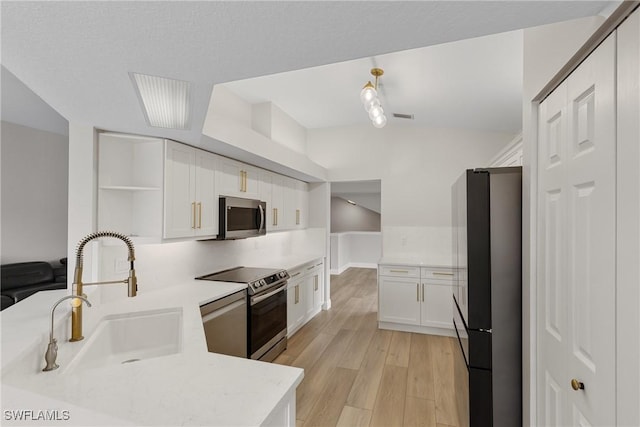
[224, 30, 523, 133]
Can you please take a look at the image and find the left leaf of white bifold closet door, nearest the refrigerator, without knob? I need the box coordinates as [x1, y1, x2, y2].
[537, 77, 568, 427]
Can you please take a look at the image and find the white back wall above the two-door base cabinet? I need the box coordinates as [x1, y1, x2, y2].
[307, 125, 514, 257]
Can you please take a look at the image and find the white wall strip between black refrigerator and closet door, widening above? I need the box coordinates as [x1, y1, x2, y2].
[522, 16, 604, 426]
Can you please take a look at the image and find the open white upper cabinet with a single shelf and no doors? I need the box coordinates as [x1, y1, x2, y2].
[97, 132, 164, 244]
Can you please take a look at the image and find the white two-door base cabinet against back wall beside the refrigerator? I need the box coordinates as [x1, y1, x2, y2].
[378, 265, 457, 335]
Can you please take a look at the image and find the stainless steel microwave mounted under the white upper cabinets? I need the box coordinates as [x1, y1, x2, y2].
[217, 196, 267, 240]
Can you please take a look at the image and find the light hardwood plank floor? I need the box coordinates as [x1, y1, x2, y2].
[275, 268, 459, 427]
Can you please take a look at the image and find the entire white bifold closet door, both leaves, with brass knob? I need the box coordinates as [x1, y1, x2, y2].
[538, 35, 616, 426]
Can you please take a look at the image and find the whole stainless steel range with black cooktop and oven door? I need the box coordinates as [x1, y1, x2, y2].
[196, 267, 289, 362]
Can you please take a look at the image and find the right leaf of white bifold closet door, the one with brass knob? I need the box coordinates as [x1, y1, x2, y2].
[567, 34, 616, 426]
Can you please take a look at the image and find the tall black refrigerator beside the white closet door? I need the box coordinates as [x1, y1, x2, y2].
[452, 167, 522, 427]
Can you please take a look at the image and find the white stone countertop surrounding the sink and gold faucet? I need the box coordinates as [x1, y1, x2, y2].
[0, 274, 314, 426]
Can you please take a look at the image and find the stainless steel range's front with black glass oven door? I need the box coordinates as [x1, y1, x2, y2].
[248, 281, 287, 361]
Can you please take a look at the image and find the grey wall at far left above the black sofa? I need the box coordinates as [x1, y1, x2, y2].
[1, 121, 69, 264]
